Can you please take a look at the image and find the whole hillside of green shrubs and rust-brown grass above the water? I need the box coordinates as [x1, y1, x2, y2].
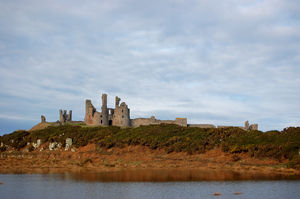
[0, 124, 300, 175]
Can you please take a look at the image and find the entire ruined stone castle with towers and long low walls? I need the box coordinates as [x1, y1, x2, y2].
[40, 94, 258, 131]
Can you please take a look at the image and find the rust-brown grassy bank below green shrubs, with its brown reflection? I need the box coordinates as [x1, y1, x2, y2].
[0, 144, 300, 181]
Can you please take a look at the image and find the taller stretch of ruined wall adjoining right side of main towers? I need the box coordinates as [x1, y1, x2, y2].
[131, 116, 187, 127]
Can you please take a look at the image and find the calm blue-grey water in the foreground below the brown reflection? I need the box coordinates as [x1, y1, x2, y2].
[0, 174, 300, 199]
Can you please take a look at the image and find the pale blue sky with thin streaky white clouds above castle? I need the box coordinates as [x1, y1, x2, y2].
[0, 0, 300, 135]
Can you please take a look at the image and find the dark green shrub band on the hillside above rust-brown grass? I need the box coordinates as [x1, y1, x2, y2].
[0, 125, 300, 165]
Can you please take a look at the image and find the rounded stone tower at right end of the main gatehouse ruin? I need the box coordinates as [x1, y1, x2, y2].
[112, 97, 130, 127]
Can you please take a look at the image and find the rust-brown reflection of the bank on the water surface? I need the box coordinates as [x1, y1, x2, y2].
[61, 169, 300, 182]
